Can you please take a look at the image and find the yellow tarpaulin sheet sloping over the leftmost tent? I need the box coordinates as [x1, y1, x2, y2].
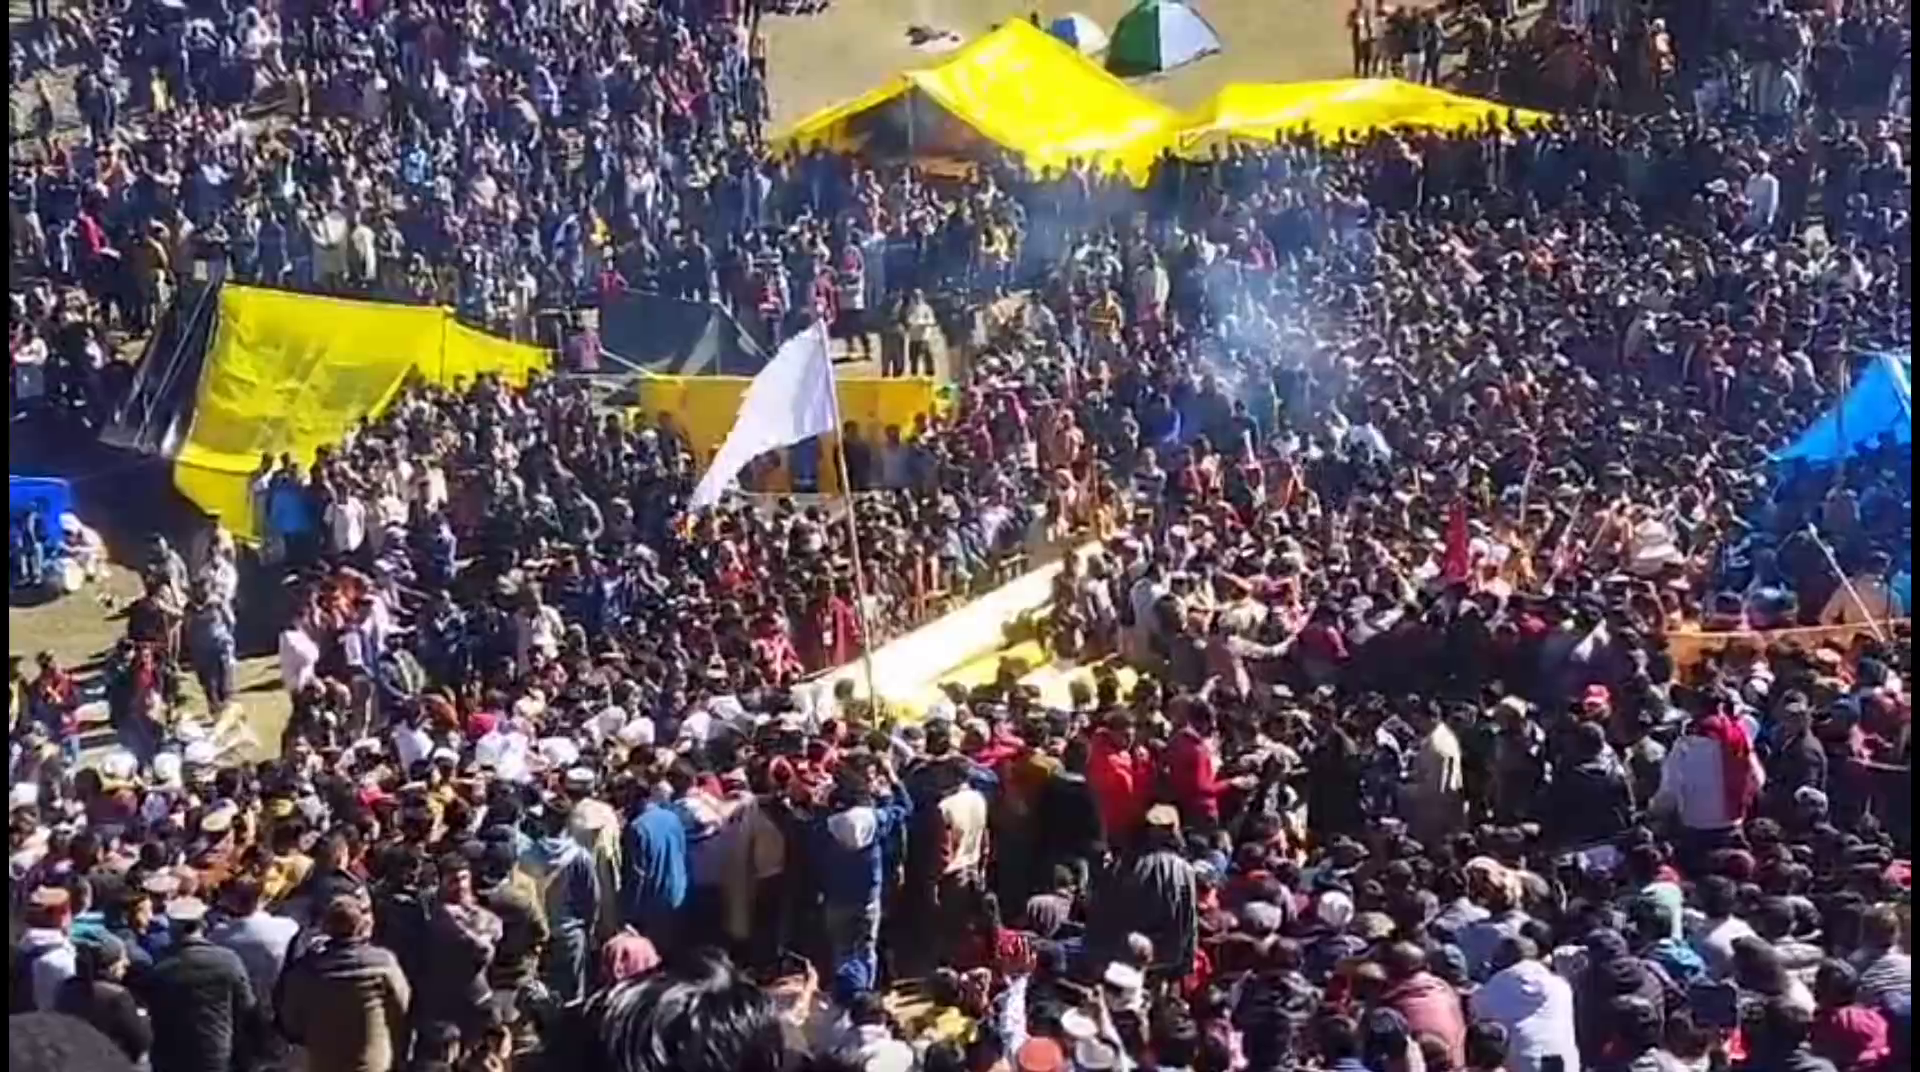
[173, 286, 545, 538]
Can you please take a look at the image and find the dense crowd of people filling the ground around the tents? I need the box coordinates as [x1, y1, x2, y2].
[10, 0, 1912, 1072]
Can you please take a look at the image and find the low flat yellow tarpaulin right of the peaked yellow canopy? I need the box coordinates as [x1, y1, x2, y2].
[1177, 79, 1549, 156]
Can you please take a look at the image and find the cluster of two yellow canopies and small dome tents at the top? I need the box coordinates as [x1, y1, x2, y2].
[785, 17, 1546, 183]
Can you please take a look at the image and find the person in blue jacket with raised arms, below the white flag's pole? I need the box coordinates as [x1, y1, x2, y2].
[816, 759, 914, 993]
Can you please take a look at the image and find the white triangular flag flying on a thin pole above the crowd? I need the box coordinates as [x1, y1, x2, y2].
[687, 323, 839, 509]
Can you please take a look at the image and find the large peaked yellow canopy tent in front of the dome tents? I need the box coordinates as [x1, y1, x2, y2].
[783, 19, 1177, 183]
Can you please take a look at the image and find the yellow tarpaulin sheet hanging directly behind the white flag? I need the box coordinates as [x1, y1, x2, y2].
[637, 375, 935, 492]
